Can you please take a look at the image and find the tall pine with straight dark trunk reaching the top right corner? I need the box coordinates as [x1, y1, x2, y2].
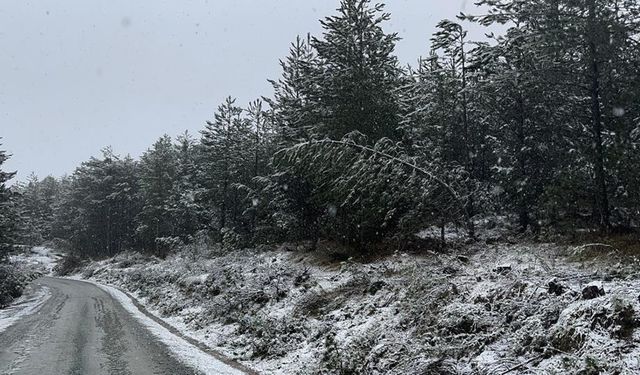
[468, 0, 639, 230]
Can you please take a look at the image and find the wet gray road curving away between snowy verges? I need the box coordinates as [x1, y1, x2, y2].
[0, 277, 248, 375]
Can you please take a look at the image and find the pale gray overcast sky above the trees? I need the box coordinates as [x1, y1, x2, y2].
[0, 0, 496, 179]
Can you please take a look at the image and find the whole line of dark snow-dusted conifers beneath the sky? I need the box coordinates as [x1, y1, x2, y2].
[0, 0, 640, 255]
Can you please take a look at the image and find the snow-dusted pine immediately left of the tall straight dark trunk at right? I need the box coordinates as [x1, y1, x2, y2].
[472, 25, 564, 231]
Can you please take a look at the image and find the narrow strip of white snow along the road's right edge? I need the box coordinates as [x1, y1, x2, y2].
[74, 281, 244, 375]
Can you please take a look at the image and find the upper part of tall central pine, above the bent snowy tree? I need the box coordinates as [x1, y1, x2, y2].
[310, 0, 401, 143]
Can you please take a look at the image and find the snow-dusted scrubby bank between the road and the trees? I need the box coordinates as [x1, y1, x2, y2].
[69, 228, 640, 374]
